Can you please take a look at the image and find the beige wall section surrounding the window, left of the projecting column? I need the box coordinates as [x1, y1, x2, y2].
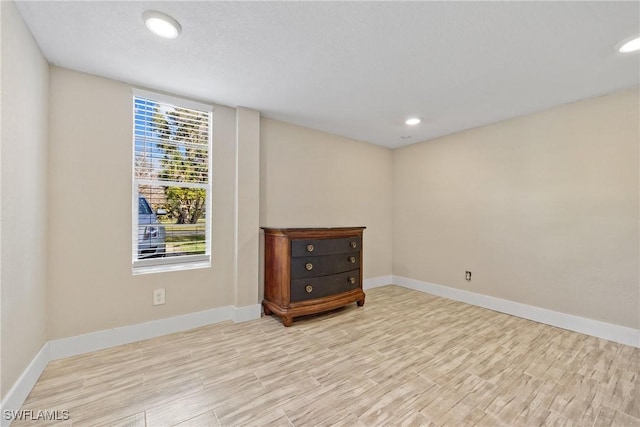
[48, 67, 246, 339]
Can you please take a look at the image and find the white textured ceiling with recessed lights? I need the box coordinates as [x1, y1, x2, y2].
[18, 1, 640, 147]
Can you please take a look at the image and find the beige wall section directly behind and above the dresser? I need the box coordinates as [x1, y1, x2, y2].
[260, 118, 393, 279]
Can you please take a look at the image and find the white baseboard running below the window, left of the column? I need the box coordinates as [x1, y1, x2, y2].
[49, 306, 232, 360]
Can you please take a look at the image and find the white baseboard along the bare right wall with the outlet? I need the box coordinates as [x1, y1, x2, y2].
[393, 275, 640, 348]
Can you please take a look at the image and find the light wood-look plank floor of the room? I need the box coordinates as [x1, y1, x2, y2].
[12, 286, 640, 427]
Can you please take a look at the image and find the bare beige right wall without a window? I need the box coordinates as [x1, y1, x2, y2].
[393, 88, 640, 328]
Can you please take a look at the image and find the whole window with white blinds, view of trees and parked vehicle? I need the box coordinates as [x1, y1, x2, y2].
[132, 90, 212, 273]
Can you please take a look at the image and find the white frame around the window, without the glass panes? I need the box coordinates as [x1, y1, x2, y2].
[131, 88, 214, 275]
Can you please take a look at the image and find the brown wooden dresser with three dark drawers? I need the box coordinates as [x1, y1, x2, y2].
[262, 227, 365, 326]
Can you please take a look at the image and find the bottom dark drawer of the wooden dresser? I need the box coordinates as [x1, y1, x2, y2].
[291, 270, 360, 302]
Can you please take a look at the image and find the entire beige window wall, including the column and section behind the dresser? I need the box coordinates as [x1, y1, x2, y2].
[48, 67, 392, 339]
